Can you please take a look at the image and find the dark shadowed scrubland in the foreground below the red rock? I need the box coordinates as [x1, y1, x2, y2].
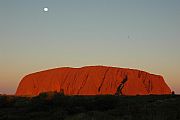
[0, 92, 180, 120]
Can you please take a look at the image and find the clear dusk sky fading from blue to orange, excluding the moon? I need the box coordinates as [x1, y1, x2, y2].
[0, 0, 180, 94]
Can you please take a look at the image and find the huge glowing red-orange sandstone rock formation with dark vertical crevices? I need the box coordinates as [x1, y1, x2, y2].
[16, 66, 171, 96]
